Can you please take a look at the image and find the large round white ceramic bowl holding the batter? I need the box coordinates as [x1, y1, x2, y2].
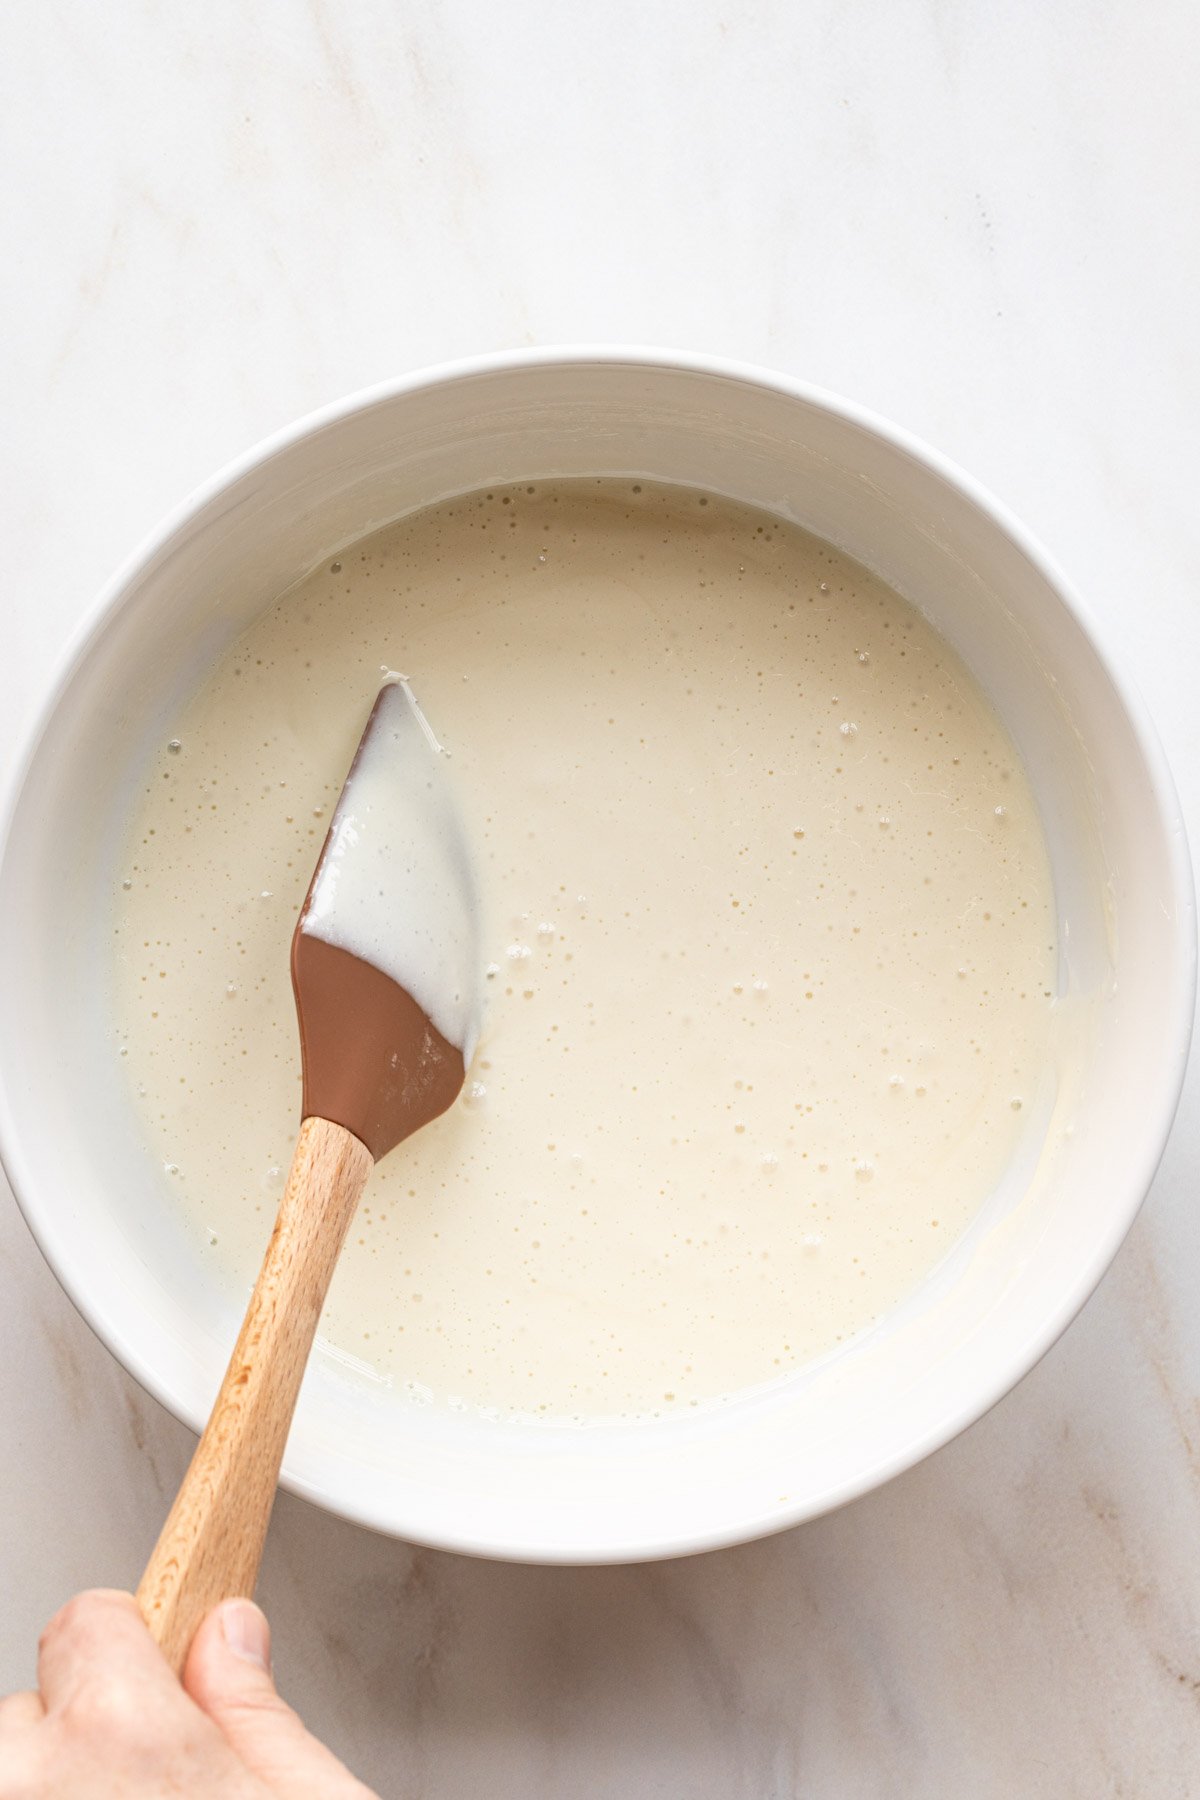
[0, 349, 1195, 1562]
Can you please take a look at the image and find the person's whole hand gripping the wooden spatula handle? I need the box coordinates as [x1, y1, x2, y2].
[0, 1589, 376, 1800]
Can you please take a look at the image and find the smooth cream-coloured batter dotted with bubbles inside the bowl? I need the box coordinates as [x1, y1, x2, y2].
[107, 481, 1054, 1418]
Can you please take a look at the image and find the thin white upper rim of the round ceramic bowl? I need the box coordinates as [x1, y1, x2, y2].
[0, 342, 1196, 1564]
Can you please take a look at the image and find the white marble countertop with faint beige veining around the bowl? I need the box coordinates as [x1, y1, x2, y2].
[0, 0, 1200, 1800]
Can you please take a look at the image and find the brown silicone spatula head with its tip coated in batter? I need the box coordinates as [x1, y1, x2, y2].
[291, 677, 479, 1161]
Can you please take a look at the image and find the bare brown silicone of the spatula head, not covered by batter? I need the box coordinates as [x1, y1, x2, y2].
[291, 684, 466, 1163]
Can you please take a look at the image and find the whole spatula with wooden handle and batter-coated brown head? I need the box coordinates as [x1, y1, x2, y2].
[137, 677, 479, 1670]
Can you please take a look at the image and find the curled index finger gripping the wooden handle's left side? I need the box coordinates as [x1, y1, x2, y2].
[38, 1588, 182, 1712]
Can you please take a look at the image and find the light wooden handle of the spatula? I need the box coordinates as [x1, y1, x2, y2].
[137, 1118, 372, 1672]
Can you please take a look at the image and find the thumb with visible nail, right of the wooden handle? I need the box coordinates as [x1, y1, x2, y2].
[184, 1600, 372, 1800]
